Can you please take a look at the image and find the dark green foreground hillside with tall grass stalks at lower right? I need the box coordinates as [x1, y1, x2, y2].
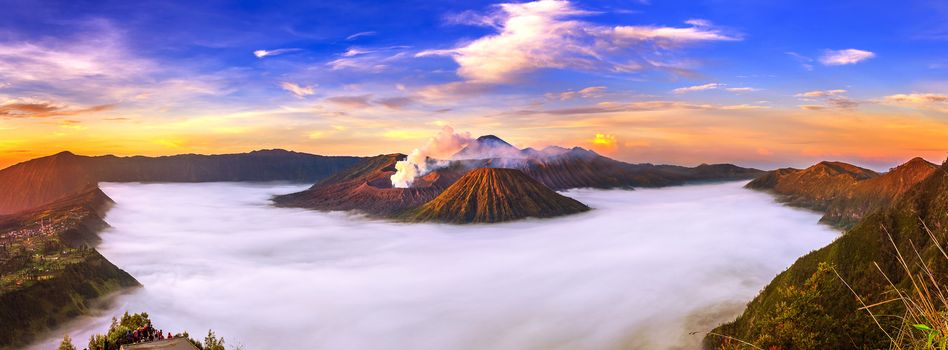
[705, 163, 948, 349]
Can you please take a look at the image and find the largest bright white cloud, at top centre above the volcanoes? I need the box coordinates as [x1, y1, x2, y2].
[416, 0, 739, 84]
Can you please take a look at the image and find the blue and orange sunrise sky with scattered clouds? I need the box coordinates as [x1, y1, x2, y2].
[0, 0, 948, 170]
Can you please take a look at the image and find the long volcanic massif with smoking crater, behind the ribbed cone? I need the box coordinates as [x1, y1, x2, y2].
[274, 135, 762, 217]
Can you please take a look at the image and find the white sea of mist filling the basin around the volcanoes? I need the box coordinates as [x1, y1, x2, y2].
[29, 182, 838, 349]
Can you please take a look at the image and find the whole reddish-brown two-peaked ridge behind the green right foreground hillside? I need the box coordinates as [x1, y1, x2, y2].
[747, 158, 938, 228]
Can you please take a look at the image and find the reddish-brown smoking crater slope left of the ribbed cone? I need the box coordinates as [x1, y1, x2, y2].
[273, 154, 460, 216]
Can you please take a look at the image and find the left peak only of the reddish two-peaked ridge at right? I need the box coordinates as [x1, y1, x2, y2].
[746, 161, 879, 211]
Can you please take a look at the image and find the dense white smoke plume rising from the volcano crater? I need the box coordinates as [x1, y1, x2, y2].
[392, 125, 472, 188]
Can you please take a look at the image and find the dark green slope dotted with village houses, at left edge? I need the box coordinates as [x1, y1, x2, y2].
[0, 188, 139, 348]
